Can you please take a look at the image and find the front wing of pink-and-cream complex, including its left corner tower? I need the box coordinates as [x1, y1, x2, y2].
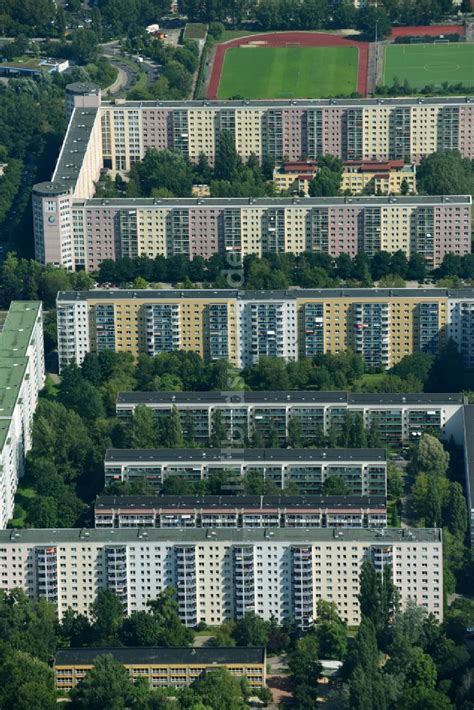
[33, 192, 471, 271]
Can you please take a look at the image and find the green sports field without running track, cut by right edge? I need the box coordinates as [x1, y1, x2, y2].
[383, 42, 474, 88]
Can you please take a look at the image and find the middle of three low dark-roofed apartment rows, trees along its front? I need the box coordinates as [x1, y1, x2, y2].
[104, 454, 387, 496]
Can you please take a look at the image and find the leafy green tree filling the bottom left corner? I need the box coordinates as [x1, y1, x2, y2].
[0, 651, 57, 710]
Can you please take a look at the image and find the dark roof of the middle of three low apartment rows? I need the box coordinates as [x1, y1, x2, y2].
[105, 448, 387, 464]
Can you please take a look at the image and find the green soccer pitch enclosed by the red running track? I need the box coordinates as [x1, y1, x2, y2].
[218, 46, 359, 99]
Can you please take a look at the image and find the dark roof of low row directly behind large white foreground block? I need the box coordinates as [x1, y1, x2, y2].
[95, 495, 386, 511]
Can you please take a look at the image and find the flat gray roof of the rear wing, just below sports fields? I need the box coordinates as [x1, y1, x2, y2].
[102, 96, 474, 111]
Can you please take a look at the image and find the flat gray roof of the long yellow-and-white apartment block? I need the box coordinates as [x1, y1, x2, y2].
[57, 288, 474, 302]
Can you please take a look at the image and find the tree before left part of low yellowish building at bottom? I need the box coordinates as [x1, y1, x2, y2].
[71, 653, 137, 710]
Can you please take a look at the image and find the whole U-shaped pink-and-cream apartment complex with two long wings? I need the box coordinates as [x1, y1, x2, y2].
[33, 84, 474, 270]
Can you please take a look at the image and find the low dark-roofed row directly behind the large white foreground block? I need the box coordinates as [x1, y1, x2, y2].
[94, 495, 387, 529]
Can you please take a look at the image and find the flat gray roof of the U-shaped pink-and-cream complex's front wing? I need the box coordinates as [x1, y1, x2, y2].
[79, 193, 472, 210]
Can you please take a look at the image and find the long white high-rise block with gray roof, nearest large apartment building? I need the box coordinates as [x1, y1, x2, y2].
[0, 528, 443, 627]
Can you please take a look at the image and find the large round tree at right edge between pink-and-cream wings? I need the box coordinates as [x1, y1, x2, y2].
[416, 150, 473, 195]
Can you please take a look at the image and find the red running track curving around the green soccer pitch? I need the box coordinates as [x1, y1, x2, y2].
[207, 32, 369, 100]
